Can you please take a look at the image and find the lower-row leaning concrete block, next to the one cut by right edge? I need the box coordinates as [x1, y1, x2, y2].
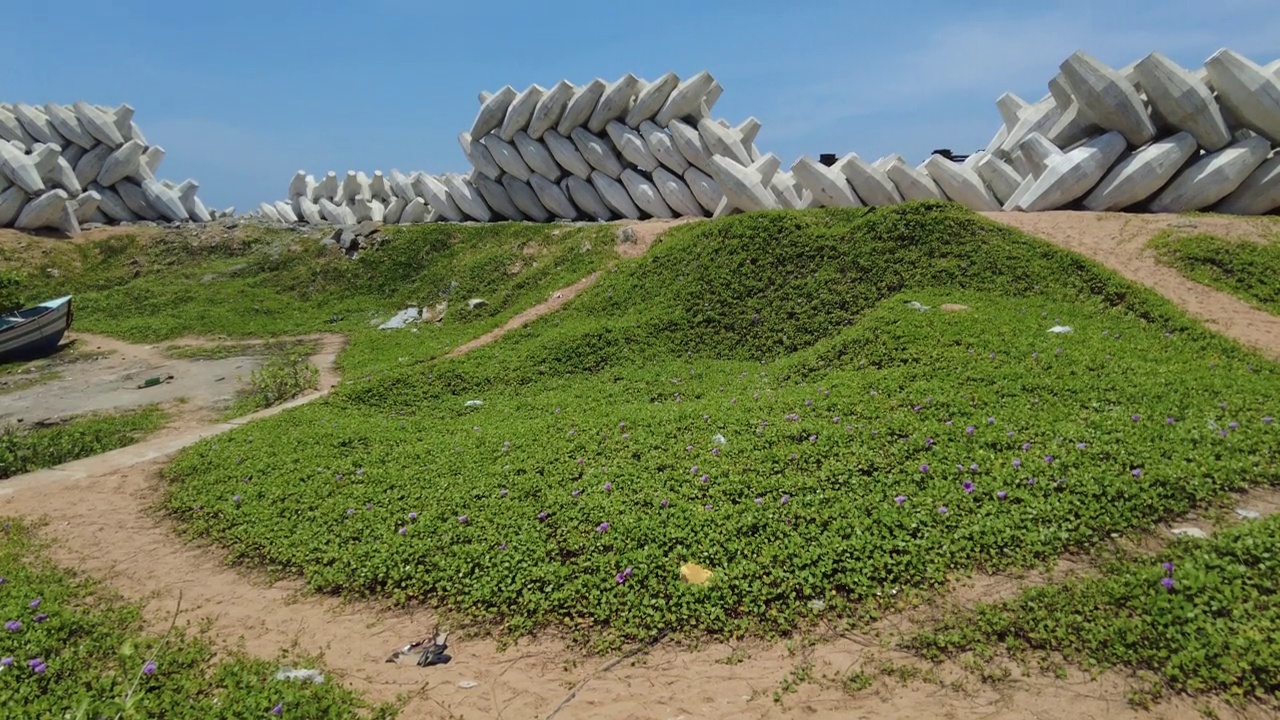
[1148, 135, 1271, 213]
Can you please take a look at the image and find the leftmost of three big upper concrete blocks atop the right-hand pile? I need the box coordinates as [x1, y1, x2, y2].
[1060, 53, 1156, 146]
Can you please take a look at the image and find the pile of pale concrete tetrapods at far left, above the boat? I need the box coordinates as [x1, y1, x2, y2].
[0, 101, 222, 236]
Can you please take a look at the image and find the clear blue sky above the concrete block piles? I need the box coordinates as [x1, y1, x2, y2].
[0, 0, 1280, 210]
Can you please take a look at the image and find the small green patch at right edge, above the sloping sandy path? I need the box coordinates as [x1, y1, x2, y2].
[1151, 232, 1280, 315]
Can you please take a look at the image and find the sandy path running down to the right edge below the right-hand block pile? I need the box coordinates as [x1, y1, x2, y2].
[983, 211, 1280, 360]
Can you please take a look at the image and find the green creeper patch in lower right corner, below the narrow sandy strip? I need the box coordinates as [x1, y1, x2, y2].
[911, 516, 1280, 702]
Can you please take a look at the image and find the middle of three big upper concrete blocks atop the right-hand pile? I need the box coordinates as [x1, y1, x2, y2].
[1134, 53, 1231, 152]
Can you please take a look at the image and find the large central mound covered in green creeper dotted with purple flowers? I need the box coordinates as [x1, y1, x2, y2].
[160, 204, 1280, 637]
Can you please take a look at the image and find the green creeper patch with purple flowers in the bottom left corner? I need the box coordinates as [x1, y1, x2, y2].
[0, 520, 396, 720]
